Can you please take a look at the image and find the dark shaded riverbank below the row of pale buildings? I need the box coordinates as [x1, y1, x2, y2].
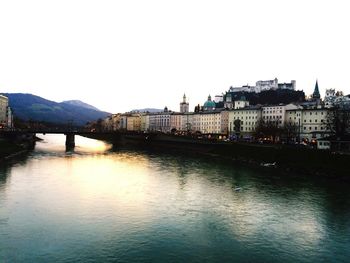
[84, 134, 350, 181]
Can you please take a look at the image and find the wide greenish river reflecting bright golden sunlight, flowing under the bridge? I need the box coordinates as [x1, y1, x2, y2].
[0, 135, 350, 262]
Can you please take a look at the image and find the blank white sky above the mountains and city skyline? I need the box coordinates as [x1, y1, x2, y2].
[0, 0, 350, 113]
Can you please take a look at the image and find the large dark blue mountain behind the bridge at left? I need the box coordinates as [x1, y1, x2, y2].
[4, 93, 110, 125]
